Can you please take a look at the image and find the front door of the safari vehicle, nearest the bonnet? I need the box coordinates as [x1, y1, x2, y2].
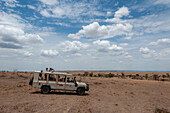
[65, 76, 76, 91]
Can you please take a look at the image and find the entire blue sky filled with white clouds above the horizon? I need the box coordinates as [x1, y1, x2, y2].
[0, 0, 170, 71]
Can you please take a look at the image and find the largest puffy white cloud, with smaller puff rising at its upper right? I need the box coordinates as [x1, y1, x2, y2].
[68, 7, 133, 39]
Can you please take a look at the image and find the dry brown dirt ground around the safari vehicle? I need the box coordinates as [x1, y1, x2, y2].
[0, 72, 170, 113]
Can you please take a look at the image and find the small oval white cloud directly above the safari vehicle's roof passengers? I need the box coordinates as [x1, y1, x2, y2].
[41, 49, 59, 57]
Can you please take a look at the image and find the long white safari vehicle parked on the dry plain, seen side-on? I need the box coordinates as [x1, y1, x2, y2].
[29, 71, 89, 95]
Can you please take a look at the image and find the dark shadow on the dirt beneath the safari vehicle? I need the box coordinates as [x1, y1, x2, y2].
[30, 91, 89, 96]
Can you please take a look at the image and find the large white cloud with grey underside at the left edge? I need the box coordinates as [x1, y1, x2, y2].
[0, 12, 44, 49]
